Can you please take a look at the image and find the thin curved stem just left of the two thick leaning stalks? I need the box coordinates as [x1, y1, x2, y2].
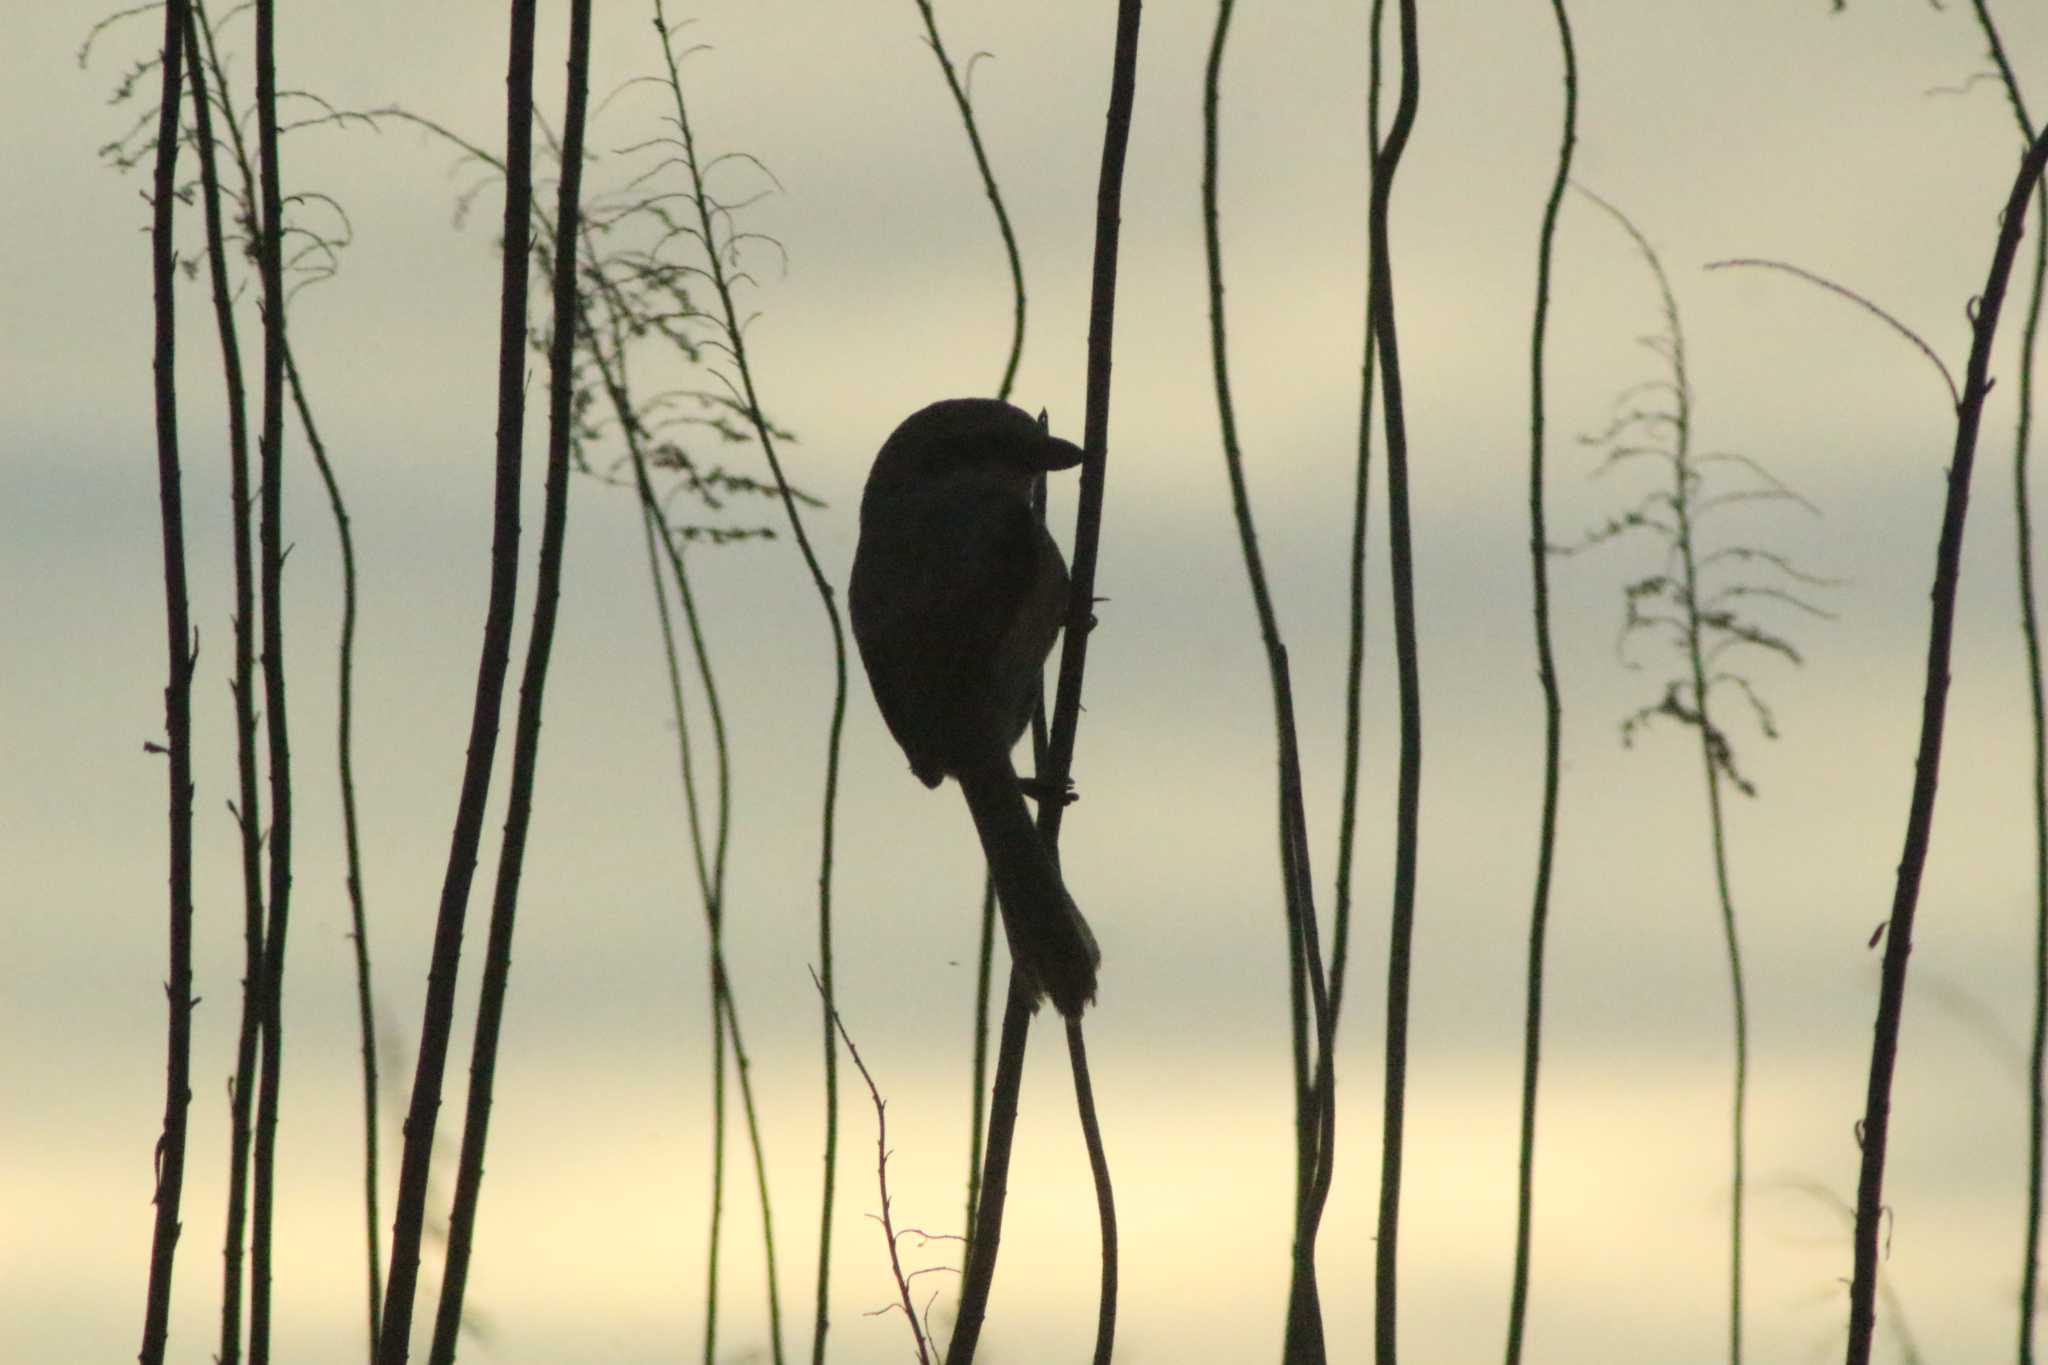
[285, 334, 383, 1351]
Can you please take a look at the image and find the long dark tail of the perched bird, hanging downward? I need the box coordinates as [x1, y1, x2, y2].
[956, 753, 1102, 1017]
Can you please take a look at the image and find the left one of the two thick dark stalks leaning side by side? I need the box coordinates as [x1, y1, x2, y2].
[377, 0, 535, 1365]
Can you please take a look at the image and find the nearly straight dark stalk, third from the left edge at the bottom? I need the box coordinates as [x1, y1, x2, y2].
[250, 0, 291, 1365]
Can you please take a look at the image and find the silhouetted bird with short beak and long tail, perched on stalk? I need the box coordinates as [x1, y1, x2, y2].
[848, 399, 1102, 1019]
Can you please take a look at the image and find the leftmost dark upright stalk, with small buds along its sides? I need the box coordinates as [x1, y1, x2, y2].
[137, 0, 197, 1365]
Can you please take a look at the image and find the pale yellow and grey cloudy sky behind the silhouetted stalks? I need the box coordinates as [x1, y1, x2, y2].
[0, 0, 2048, 1365]
